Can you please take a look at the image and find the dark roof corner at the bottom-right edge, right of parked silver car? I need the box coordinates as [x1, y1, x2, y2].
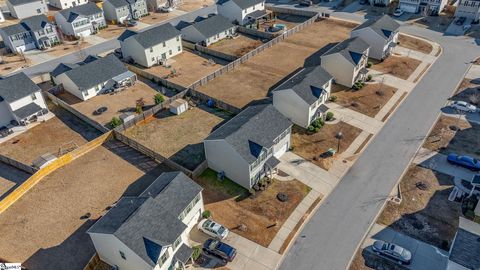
[449, 228, 480, 269]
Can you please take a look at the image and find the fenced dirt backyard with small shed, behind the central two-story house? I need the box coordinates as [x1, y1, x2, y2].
[126, 106, 230, 170]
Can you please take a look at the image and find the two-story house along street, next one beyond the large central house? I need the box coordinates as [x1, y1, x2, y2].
[273, 66, 333, 128]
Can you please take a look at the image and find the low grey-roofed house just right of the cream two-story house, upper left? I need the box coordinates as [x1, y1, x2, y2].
[177, 15, 236, 46]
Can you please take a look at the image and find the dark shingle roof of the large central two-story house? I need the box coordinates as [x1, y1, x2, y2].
[205, 104, 292, 163]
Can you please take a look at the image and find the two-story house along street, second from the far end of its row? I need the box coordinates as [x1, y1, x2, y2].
[320, 37, 370, 87]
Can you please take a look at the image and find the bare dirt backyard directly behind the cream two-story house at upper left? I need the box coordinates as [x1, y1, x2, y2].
[145, 51, 225, 87]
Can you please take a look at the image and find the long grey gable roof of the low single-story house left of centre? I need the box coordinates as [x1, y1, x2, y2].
[51, 54, 128, 90]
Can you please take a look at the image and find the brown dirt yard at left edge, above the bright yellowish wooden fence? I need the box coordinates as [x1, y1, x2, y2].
[0, 105, 100, 164]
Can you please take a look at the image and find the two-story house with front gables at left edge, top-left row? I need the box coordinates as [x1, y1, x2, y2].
[0, 15, 60, 53]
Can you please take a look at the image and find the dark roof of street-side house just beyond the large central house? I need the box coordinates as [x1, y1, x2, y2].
[274, 66, 333, 105]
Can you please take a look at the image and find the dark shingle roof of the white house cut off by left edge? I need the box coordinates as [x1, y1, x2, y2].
[0, 72, 40, 103]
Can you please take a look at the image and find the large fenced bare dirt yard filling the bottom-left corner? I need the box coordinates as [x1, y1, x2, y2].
[0, 141, 172, 270]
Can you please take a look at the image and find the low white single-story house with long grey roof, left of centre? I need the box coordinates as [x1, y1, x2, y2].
[51, 54, 137, 101]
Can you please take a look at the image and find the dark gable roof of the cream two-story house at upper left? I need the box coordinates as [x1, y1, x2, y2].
[118, 23, 181, 49]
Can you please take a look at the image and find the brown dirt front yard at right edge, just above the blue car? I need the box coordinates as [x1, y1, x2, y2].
[423, 115, 480, 159]
